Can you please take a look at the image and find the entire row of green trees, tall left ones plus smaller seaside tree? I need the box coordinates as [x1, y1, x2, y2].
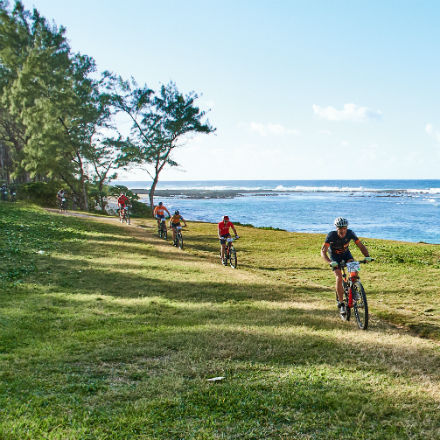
[0, 0, 215, 209]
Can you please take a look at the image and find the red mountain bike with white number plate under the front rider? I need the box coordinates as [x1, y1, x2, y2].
[336, 259, 374, 330]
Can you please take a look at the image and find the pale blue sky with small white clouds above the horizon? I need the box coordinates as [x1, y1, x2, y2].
[23, 0, 440, 180]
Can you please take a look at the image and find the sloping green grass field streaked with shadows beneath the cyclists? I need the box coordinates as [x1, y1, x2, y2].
[0, 203, 440, 440]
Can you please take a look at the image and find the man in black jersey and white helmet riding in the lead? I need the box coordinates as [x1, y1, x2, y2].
[321, 217, 371, 314]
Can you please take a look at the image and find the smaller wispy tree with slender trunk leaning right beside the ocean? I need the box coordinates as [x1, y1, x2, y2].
[105, 73, 216, 209]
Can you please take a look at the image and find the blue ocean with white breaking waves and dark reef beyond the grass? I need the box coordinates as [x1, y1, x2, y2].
[116, 180, 440, 244]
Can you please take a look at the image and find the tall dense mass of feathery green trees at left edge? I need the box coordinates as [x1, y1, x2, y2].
[0, 0, 126, 209]
